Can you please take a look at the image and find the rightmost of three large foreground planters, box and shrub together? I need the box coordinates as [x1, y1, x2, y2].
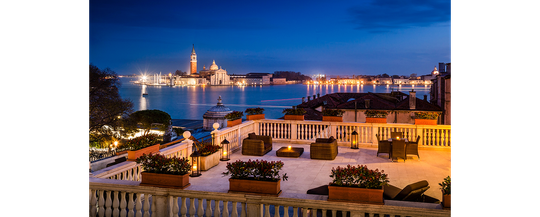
[328, 165, 389, 205]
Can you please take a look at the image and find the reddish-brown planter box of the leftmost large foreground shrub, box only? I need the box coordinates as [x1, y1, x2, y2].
[140, 172, 191, 189]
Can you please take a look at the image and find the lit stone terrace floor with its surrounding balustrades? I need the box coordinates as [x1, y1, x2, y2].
[89, 119, 451, 216]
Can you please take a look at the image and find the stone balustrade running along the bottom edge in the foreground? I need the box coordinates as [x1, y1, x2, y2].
[88, 178, 451, 217]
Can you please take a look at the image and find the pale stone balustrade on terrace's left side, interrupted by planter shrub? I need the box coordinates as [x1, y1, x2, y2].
[92, 140, 193, 181]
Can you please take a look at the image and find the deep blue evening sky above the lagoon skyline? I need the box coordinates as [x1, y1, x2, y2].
[89, 0, 451, 76]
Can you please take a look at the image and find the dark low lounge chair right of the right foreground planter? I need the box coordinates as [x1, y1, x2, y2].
[383, 180, 433, 202]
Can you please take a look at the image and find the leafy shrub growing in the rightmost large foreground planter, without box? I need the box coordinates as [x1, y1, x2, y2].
[330, 165, 389, 189]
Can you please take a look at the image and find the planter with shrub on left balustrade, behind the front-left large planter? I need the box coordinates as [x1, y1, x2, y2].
[119, 133, 163, 161]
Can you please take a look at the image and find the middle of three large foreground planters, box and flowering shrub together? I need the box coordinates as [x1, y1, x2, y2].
[223, 159, 288, 196]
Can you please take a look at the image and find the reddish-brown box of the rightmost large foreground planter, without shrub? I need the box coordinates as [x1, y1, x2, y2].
[328, 185, 384, 205]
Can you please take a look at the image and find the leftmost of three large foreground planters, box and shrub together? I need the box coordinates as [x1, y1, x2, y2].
[137, 154, 191, 189]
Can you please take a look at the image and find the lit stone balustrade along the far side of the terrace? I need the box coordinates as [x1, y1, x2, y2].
[214, 119, 452, 149]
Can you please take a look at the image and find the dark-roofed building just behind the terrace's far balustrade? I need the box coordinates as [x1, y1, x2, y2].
[297, 91, 442, 124]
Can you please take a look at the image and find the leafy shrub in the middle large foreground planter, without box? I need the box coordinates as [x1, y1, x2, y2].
[223, 159, 289, 181]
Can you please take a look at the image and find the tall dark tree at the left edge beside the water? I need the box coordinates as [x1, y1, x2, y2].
[88, 64, 133, 146]
